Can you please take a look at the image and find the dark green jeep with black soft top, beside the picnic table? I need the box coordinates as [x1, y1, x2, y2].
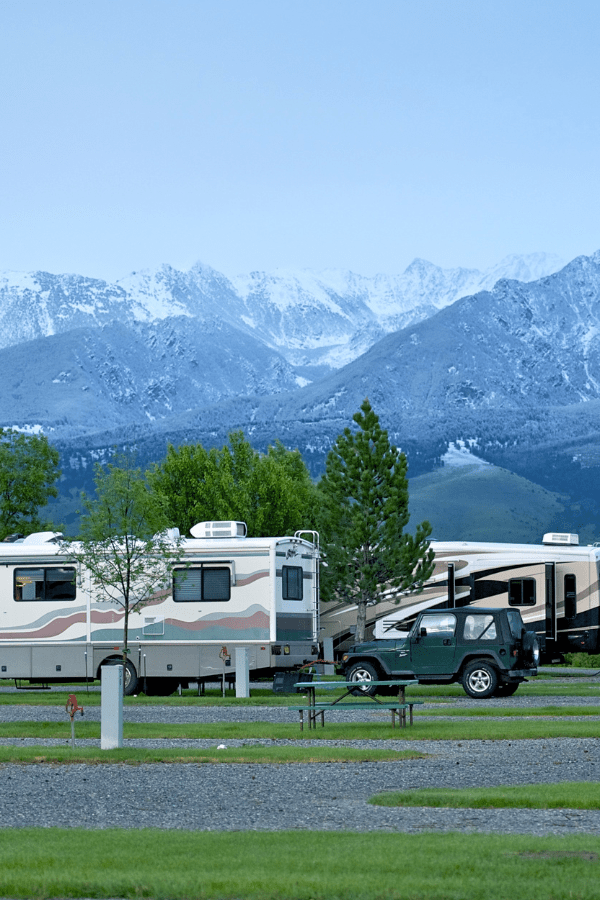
[342, 606, 540, 699]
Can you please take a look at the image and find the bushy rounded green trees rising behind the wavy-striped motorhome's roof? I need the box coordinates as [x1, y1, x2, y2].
[151, 431, 317, 537]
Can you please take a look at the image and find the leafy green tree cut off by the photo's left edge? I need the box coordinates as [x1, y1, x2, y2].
[0, 428, 60, 540]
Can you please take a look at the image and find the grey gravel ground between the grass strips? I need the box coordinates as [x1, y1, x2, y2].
[0, 697, 600, 835]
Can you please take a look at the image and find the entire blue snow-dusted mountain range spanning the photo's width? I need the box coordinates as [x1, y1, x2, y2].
[0, 248, 580, 458]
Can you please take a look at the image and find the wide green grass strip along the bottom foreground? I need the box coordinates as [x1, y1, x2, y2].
[0, 828, 600, 900]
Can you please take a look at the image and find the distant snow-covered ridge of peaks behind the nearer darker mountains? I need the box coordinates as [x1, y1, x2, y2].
[0, 254, 561, 380]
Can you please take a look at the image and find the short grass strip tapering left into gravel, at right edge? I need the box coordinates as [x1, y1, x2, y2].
[369, 781, 600, 809]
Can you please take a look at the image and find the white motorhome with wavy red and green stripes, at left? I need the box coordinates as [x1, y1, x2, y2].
[0, 522, 319, 694]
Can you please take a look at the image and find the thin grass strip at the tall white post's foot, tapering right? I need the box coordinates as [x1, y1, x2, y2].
[0, 744, 427, 765]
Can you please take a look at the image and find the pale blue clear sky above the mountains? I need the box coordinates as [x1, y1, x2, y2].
[0, 0, 600, 279]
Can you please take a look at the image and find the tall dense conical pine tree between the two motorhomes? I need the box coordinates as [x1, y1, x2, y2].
[319, 400, 433, 642]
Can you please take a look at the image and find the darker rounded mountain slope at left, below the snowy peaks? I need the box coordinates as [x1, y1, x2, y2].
[0, 316, 298, 437]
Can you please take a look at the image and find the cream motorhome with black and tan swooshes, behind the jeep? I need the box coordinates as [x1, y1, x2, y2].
[321, 533, 600, 658]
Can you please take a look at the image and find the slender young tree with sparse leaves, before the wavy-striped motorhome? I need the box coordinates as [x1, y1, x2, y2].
[65, 456, 182, 687]
